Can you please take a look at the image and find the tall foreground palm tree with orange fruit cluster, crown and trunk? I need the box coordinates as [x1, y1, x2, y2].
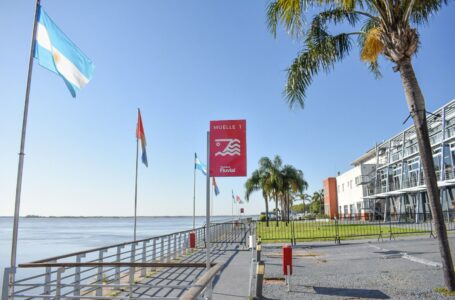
[267, 0, 455, 291]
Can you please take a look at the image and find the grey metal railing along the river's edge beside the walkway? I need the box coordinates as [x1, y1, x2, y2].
[2, 221, 250, 300]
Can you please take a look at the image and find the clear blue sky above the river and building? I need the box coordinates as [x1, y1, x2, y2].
[0, 0, 455, 216]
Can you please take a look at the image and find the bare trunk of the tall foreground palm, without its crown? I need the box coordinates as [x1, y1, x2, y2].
[399, 58, 455, 291]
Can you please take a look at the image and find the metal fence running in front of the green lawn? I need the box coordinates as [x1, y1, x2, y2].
[256, 211, 455, 243]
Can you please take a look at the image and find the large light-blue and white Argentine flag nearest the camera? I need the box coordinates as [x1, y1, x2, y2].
[34, 6, 95, 97]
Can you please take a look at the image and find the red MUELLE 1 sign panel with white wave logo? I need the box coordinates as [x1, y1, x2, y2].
[209, 120, 246, 177]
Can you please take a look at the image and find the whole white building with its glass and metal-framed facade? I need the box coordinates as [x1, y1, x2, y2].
[330, 99, 455, 221]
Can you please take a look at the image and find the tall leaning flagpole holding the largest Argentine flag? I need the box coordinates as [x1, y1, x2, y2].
[9, 0, 40, 297]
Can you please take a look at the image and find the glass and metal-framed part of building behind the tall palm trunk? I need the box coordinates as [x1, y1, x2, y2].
[366, 99, 455, 218]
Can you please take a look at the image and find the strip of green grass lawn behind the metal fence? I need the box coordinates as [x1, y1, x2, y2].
[256, 221, 429, 242]
